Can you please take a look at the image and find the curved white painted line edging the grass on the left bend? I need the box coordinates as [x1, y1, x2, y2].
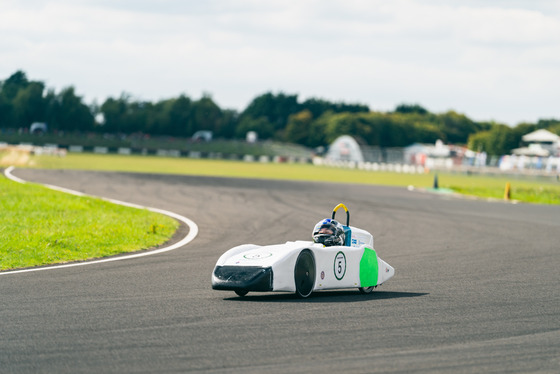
[0, 166, 198, 275]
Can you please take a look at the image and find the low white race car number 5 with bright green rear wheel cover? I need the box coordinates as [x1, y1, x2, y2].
[212, 204, 395, 297]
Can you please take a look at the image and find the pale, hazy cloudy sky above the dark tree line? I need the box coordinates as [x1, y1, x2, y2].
[0, 0, 560, 126]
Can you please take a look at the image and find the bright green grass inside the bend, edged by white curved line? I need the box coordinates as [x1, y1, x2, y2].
[0, 176, 179, 270]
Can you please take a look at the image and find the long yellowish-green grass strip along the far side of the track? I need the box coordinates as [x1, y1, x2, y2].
[27, 154, 560, 204]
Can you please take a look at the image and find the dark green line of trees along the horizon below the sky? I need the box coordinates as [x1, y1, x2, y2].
[0, 71, 560, 155]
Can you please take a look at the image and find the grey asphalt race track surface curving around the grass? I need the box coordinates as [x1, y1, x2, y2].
[0, 169, 560, 373]
